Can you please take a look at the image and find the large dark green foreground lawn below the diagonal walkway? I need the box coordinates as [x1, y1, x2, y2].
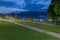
[0, 20, 60, 40]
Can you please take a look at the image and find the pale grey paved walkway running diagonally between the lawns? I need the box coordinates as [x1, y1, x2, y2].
[0, 20, 60, 39]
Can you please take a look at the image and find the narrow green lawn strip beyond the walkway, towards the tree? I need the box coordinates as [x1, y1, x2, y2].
[15, 21, 60, 33]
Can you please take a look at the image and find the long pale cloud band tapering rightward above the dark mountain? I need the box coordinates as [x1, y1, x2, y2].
[0, 6, 29, 14]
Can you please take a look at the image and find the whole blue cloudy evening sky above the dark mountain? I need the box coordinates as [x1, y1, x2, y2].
[0, 0, 51, 13]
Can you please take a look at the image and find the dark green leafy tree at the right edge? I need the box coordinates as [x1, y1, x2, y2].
[48, 0, 60, 23]
